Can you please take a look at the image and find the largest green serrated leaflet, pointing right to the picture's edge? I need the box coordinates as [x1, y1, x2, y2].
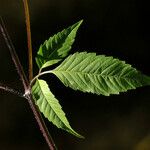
[51, 52, 150, 96]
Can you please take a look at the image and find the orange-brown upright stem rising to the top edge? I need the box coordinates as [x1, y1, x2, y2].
[23, 0, 33, 81]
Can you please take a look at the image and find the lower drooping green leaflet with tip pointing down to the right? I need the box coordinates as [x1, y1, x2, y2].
[32, 79, 83, 138]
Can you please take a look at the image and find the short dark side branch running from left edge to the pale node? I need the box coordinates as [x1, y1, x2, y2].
[0, 84, 24, 97]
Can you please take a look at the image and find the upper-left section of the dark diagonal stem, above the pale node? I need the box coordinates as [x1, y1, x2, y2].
[0, 17, 29, 92]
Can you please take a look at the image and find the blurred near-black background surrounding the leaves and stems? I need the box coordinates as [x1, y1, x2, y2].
[0, 0, 150, 150]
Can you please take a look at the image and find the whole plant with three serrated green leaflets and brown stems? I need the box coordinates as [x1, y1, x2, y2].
[0, 0, 150, 150]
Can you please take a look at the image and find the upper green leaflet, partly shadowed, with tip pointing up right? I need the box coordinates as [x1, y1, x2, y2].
[36, 20, 82, 69]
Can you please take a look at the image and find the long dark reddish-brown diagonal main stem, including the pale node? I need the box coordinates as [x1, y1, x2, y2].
[0, 17, 57, 150]
